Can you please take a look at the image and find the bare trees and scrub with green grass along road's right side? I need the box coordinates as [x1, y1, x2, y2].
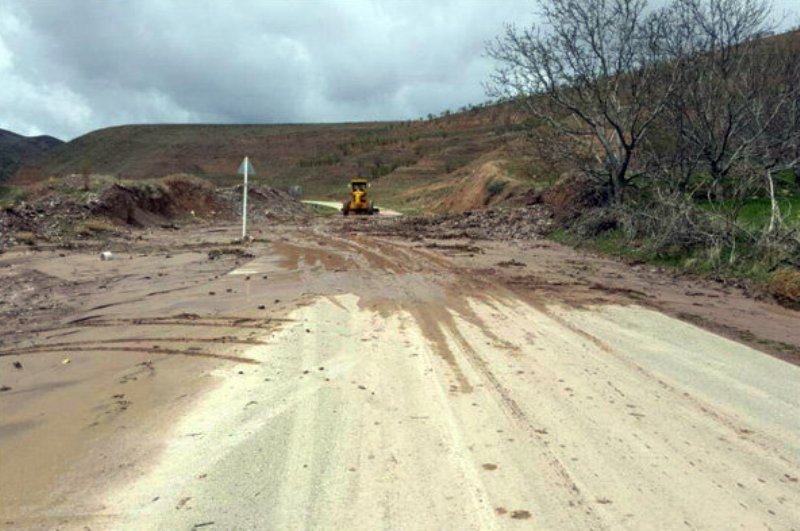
[488, 0, 800, 303]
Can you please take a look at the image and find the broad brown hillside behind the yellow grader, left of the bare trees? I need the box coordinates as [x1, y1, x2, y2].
[15, 105, 552, 211]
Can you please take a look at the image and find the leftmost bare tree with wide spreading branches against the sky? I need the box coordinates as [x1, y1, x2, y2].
[487, 0, 681, 203]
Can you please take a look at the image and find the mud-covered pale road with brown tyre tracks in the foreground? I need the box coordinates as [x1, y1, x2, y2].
[0, 218, 800, 530]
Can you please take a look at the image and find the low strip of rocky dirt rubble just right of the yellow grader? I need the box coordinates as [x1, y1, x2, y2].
[354, 205, 553, 240]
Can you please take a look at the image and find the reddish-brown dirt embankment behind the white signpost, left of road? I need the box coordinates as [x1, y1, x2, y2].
[0, 175, 305, 247]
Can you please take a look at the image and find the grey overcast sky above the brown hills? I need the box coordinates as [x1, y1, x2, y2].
[0, 0, 798, 139]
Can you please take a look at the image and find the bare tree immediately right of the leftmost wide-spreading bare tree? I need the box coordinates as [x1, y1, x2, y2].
[668, 0, 771, 199]
